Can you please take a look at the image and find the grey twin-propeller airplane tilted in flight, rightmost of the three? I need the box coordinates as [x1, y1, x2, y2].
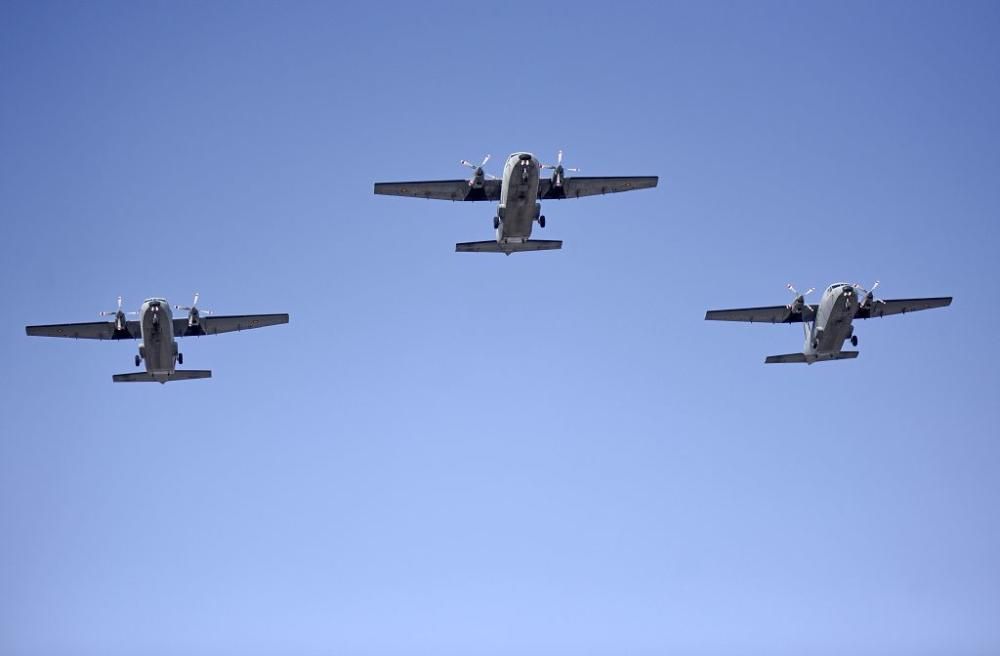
[705, 280, 951, 364]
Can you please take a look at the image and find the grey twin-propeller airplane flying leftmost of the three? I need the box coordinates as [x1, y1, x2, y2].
[25, 294, 288, 384]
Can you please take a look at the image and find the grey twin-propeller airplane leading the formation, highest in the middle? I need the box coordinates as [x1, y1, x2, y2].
[375, 150, 659, 255]
